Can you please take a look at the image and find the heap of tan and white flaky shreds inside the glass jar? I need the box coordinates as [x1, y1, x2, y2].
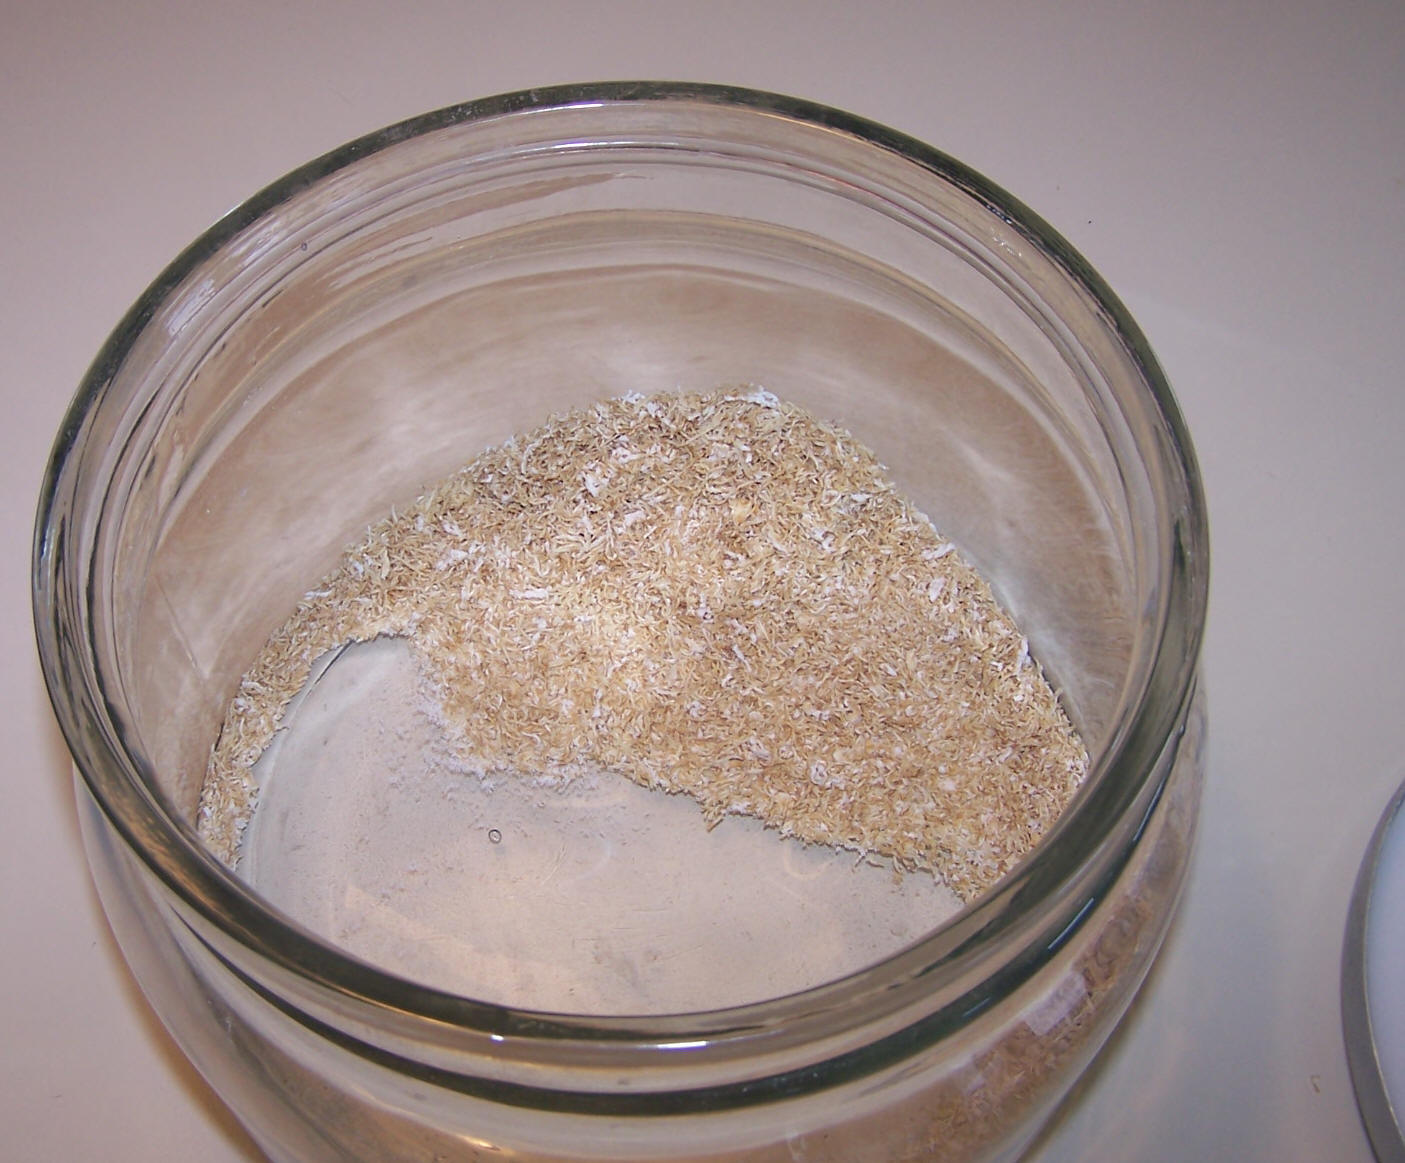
[200, 390, 1087, 900]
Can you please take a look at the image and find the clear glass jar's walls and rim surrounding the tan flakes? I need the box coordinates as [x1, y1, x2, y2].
[34, 84, 1208, 1163]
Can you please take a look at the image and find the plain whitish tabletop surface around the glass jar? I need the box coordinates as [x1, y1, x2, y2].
[0, 0, 1405, 1163]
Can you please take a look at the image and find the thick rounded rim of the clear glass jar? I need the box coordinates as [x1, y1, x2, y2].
[32, 81, 1208, 1067]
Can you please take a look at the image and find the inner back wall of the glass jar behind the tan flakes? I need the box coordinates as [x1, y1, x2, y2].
[51, 93, 1185, 1008]
